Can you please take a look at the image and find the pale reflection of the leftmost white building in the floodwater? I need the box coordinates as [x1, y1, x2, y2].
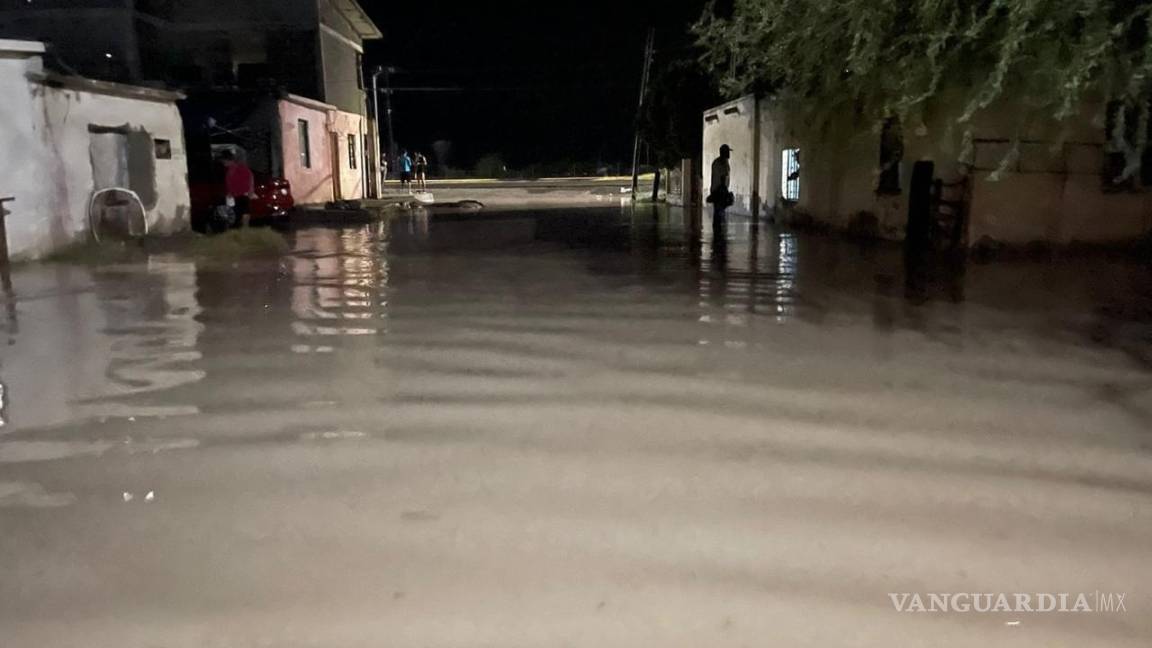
[2, 257, 205, 427]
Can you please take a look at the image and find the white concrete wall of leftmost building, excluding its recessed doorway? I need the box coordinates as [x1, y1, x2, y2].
[0, 42, 191, 258]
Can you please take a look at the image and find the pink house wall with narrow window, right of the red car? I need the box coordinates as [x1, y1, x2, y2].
[279, 99, 333, 204]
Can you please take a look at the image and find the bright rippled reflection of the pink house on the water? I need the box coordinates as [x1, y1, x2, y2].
[291, 226, 388, 353]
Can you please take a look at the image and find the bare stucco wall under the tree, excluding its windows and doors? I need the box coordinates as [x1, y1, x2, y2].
[704, 97, 1152, 243]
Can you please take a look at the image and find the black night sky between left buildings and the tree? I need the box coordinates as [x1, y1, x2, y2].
[361, 0, 704, 168]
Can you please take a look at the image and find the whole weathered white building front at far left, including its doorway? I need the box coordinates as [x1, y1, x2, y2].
[0, 40, 190, 258]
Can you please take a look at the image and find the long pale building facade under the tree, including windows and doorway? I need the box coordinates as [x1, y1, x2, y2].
[703, 96, 1152, 247]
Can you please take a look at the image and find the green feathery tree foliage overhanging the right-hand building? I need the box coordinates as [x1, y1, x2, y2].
[694, 0, 1152, 169]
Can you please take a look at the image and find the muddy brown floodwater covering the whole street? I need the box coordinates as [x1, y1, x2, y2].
[0, 209, 1152, 648]
